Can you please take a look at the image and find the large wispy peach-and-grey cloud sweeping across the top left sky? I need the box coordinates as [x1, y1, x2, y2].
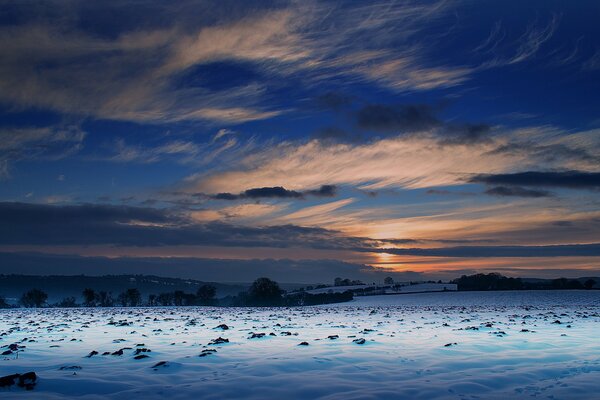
[0, 1, 471, 124]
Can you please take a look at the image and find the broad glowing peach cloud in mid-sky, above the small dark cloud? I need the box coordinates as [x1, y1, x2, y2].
[190, 135, 526, 193]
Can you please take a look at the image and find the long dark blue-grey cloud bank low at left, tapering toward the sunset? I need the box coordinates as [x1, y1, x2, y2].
[0, 203, 367, 249]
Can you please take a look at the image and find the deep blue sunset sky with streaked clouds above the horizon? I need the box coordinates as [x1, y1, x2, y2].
[0, 0, 600, 282]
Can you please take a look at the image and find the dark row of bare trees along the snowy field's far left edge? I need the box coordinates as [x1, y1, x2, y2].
[0, 278, 353, 308]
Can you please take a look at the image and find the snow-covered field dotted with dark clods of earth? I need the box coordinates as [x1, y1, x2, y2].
[0, 291, 600, 400]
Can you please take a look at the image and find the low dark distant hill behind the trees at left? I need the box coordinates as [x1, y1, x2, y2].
[0, 275, 249, 303]
